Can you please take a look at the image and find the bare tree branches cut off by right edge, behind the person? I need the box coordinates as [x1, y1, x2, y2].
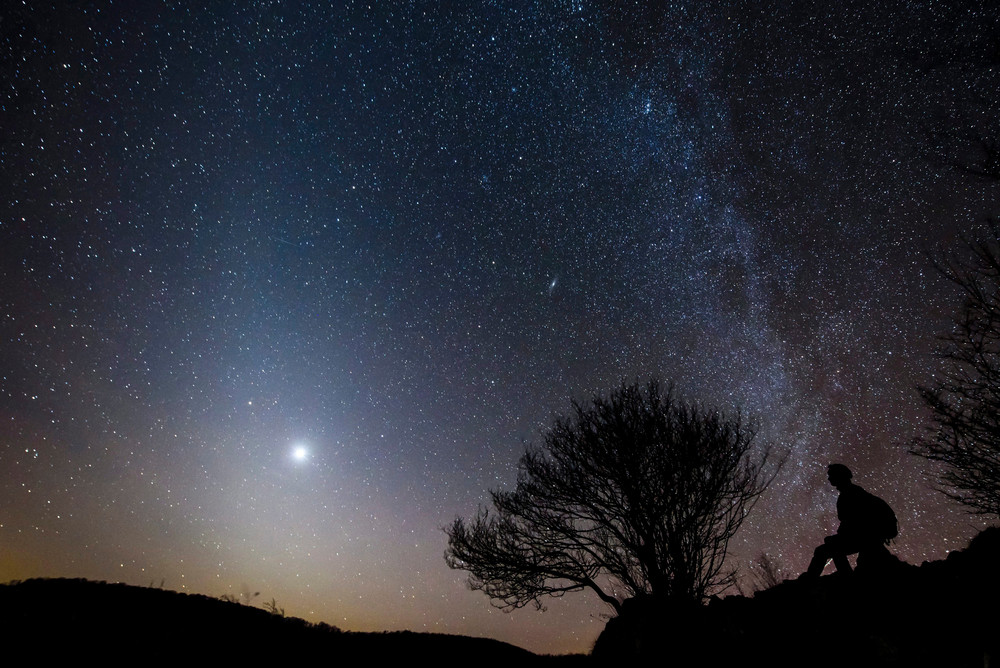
[911, 220, 1000, 516]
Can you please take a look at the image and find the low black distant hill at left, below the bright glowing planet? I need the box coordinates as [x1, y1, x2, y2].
[0, 579, 579, 666]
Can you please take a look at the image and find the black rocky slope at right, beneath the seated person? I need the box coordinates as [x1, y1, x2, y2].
[594, 527, 1000, 668]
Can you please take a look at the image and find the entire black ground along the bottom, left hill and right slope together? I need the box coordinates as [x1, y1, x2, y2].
[0, 527, 1000, 668]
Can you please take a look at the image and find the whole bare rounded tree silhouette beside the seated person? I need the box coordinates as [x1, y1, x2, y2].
[445, 381, 781, 613]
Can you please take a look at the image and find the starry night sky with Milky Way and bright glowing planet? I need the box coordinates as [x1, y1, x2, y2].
[0, 0, 1000, 652]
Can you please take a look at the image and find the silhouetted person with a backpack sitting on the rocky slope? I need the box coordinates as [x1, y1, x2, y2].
[802, 464, 897, 578]
